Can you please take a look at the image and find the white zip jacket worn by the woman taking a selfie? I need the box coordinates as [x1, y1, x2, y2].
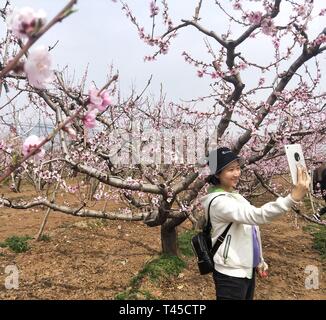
[201, 192, 297, 279]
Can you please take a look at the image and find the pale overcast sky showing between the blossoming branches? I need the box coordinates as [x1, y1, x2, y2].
[0, 0, 326, 135]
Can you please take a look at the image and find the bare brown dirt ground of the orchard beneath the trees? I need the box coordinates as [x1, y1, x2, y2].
[0, 185, 326, 300]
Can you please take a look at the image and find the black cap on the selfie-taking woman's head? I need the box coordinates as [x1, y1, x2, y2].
[207, 147, 240, 174]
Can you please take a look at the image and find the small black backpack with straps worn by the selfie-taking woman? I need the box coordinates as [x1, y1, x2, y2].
[191, 195, 232, 275]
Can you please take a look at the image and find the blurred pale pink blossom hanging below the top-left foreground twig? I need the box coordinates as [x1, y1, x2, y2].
[24, 46, 54, 89]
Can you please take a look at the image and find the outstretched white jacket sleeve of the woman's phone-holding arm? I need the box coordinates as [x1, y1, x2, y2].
[211, 195, 297, 225]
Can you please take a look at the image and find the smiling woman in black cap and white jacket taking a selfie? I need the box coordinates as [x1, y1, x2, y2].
[202, 147, 310, 300]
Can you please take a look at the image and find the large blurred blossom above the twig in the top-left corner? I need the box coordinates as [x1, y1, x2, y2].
[7, 7, 46, 39]
